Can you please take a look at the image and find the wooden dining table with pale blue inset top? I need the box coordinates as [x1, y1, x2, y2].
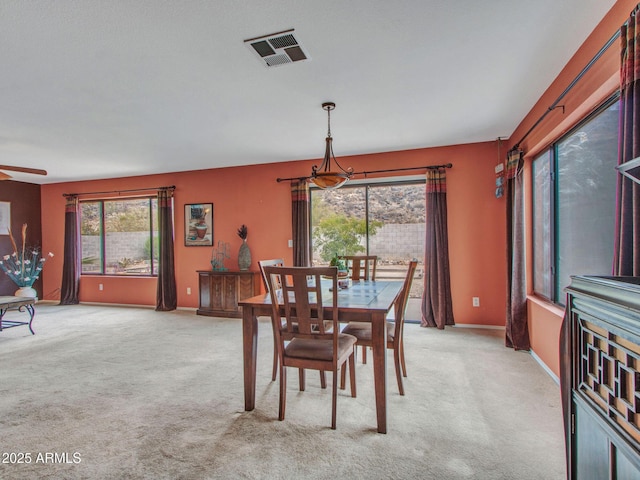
[238, 280, 402, 433]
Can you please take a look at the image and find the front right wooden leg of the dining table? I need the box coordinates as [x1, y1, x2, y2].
[371, 313, 387, 433]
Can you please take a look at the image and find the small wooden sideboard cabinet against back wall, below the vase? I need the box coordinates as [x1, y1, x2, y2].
[196, 270, 260, 318]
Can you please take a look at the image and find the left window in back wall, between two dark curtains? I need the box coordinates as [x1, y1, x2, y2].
[80, 197, 158, 275]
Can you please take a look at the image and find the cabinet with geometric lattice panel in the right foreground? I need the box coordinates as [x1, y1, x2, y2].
[560, 276, 640, 480]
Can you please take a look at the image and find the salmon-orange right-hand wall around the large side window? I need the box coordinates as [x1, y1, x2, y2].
[507, 0, 637, 377]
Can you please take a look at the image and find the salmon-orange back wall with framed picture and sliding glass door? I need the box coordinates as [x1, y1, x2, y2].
[41, 142, 506, 325]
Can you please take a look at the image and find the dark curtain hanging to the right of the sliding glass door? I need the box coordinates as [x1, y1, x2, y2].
[421, 169, 455, 329]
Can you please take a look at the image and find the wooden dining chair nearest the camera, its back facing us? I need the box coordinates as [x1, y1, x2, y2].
[264, 267, 357, 430]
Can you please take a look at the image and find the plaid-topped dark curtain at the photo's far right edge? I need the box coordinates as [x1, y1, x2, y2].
[613, 7, 640, 276]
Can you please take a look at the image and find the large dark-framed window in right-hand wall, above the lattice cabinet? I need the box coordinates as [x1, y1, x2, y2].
[533, 99, 619, 305]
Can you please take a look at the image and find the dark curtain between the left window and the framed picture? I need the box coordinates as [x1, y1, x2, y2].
[156, 188, 178, 311]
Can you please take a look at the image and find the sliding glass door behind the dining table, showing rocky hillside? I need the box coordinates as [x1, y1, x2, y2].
[310, 179, 426, 320]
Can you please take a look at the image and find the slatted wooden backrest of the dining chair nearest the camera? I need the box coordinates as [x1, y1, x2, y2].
[264, 266, 340, 342]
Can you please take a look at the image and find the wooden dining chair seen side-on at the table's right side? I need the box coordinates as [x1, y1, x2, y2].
[341, 260, 418, 395]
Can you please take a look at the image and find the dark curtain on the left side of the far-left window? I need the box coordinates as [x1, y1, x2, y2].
[60, 195, 82, 305]
